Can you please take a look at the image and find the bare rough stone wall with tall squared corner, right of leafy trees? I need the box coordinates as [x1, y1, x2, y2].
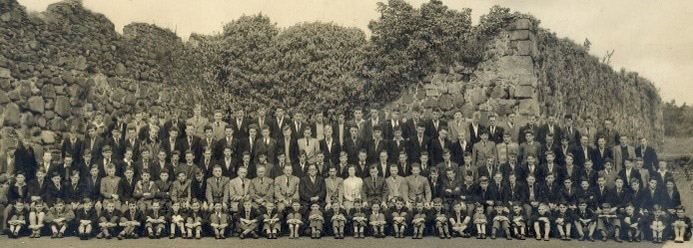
[392, 19, 541, 125]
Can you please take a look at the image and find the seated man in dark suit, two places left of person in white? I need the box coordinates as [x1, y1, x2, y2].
[298, 165, 327, 209]
